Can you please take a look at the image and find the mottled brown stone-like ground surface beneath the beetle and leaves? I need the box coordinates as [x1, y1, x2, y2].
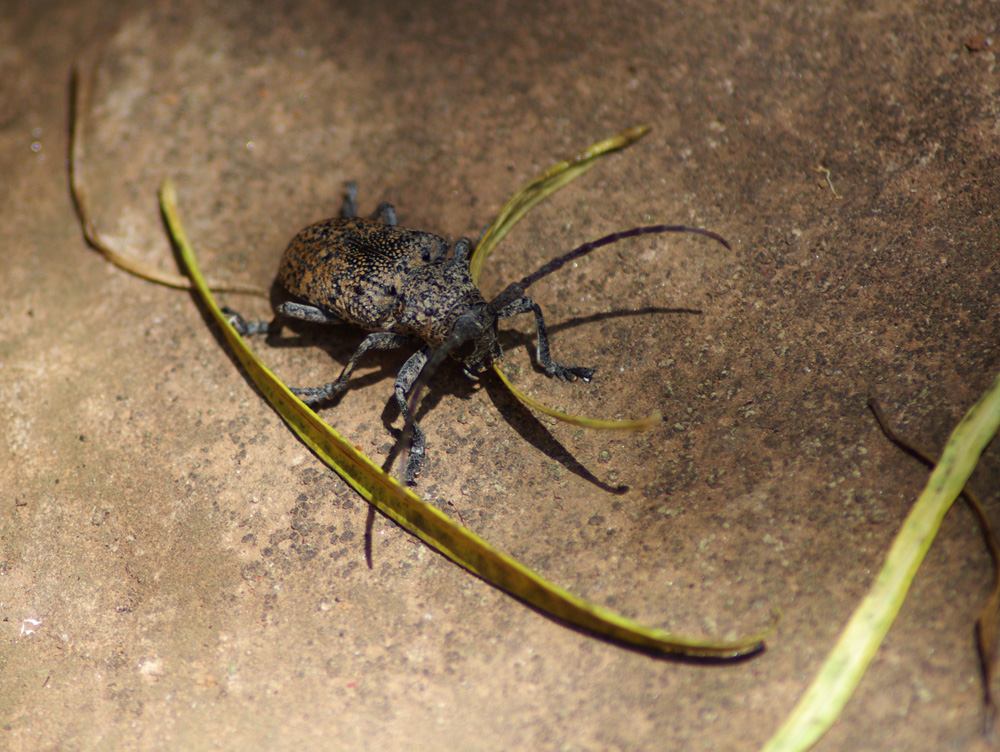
[0, 0, 1000, 750]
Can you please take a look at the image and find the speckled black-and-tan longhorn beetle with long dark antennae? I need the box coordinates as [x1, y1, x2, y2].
[225, 183, 730, 485]
